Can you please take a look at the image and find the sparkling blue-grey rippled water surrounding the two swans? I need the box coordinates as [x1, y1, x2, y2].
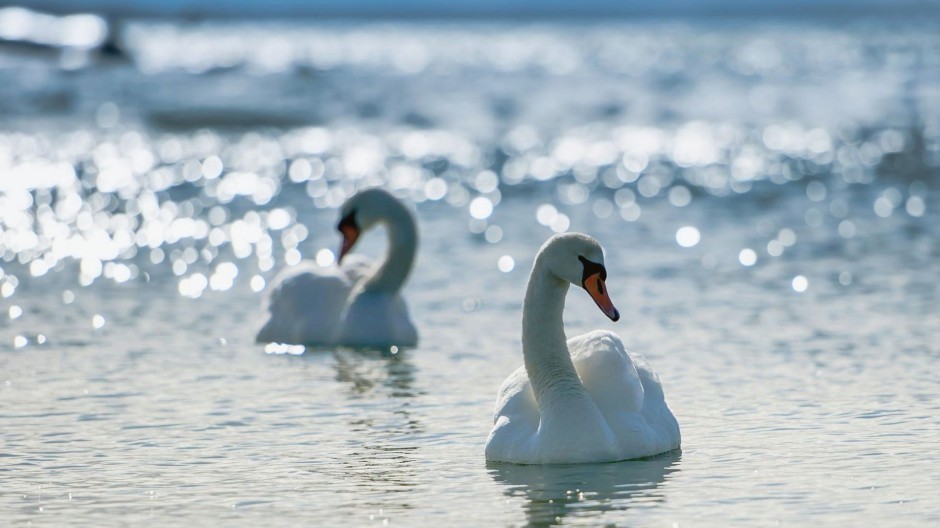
[0, 20, 940, 526]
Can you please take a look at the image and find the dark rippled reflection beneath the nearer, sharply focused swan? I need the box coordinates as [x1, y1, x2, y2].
[487, 451, 681, 526]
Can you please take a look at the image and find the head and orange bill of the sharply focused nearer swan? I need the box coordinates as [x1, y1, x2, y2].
[537, 233, 620, 321]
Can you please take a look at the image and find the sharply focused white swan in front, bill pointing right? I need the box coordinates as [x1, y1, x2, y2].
[486, 233, 679, 464]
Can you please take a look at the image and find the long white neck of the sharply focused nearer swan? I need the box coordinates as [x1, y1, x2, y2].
[522, 258, 584, 410]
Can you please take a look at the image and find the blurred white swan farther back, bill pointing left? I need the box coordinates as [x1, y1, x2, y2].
[257, 189, 418, 348]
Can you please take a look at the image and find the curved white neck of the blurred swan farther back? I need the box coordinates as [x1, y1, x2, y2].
[365, 206, 418, 293]
